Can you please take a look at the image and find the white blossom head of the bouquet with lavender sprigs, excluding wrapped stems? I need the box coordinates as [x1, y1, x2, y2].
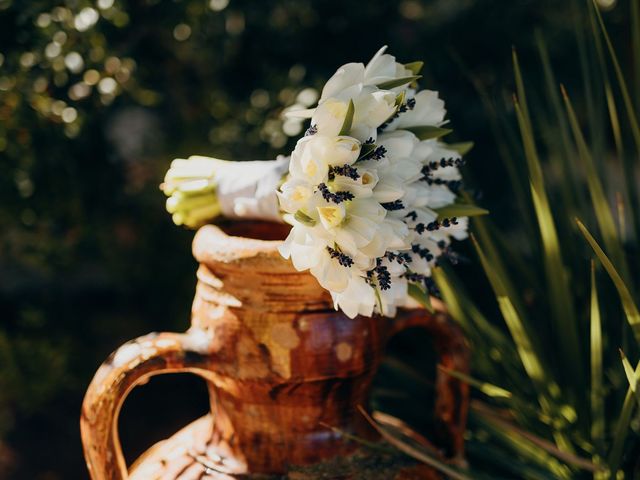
[279, 48, 468, 318]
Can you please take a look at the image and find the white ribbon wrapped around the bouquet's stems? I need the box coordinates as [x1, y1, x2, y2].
[215, 155, 289, 222]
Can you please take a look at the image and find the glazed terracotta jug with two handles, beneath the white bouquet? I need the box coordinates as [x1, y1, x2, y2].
[81, 222, 468, 480]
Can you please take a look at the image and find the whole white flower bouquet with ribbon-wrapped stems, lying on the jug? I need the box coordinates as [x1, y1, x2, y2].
[163, 47, 485, 318]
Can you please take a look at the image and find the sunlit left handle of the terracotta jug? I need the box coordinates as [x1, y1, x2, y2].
[80, 330, 211, 480]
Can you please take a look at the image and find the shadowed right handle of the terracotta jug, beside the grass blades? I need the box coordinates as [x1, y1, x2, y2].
[391, 306, 470, 458]
